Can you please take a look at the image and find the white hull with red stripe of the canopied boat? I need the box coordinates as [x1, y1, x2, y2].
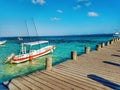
[11, 46, 55, 63]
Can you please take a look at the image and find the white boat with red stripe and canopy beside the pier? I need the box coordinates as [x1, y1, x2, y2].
[10, 41, 55, 63]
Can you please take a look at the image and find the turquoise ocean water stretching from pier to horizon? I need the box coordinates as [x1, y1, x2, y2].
[0, 34, 112, 83]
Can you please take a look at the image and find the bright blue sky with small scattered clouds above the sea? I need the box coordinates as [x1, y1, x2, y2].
[0, 0, 120, 36]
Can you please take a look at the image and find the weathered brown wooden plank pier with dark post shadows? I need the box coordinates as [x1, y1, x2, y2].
[3, 40, 120, 90]
